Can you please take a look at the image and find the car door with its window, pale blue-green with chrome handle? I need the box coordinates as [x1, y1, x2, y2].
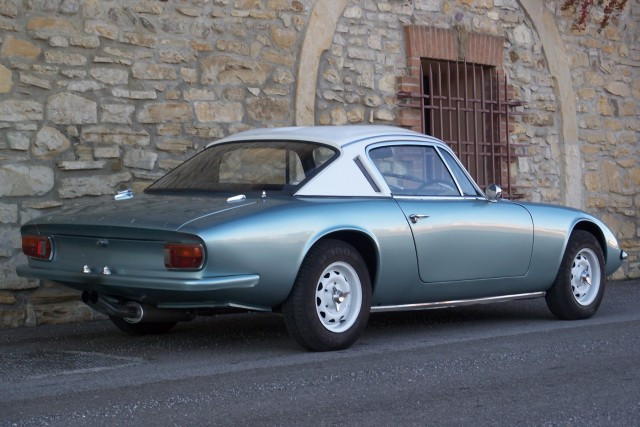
[369, 143, 533, 283]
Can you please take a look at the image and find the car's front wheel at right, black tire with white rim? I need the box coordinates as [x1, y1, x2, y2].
[545, 230, 606, 320]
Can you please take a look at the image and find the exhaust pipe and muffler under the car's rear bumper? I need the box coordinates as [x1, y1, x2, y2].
[82, 291, 196, 323]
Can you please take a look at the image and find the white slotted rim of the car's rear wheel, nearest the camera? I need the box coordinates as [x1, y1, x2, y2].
[315, 261, 362, 333]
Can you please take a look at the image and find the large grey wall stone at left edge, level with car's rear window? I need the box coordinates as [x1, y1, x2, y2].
[0, 164, 54, 197]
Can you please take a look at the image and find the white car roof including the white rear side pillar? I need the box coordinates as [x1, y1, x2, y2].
[207, 125, 451, 197]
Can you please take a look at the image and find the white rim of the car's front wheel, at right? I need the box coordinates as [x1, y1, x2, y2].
[571, 248, 601, 306]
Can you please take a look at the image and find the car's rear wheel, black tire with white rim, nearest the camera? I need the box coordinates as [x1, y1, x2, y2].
[283, 240, 371, 351]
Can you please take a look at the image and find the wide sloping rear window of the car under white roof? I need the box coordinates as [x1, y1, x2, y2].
[146, 141, 337, 192]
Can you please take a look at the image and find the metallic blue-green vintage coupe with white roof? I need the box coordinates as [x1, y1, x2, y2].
[17, 125, 627, 351]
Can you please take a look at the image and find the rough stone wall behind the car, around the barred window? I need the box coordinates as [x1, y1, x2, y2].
[0, 0, 640, 327]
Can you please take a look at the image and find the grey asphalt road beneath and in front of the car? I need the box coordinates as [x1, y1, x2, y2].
[0, 281, 640, 426]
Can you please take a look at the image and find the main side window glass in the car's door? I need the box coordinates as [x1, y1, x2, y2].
[369, 145, 460, 196]
